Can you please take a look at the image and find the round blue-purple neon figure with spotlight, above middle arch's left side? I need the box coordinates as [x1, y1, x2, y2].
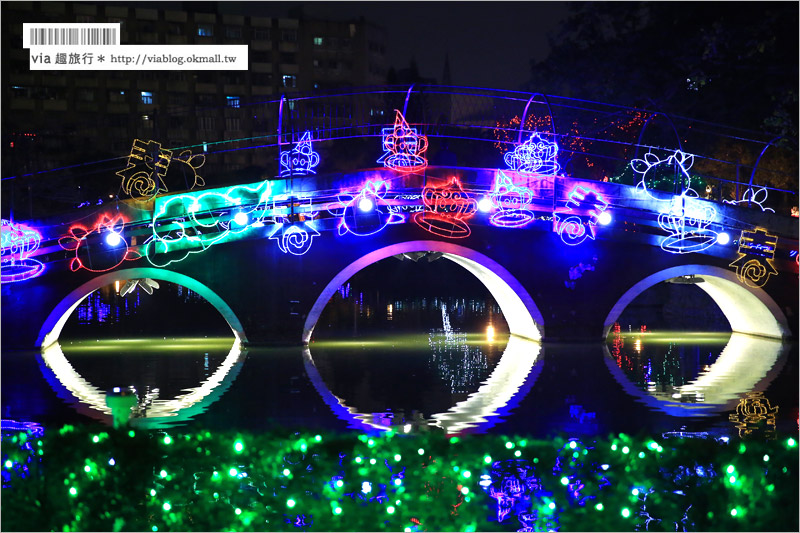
[329, 180, 405, 237]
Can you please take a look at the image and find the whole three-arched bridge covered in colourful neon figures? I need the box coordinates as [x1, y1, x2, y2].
[2, 86, 798, 348]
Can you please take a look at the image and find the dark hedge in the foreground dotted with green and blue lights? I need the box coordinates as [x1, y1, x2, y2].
[1, 426, 798, 531]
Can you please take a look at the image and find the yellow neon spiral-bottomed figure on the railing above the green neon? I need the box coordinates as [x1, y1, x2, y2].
[116, 139, 172, 199]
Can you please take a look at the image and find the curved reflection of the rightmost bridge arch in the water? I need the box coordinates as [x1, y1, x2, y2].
[603, 333, 787, 417]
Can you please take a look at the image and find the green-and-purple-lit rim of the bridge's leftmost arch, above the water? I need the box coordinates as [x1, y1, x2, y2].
[36, 267, 247, 348]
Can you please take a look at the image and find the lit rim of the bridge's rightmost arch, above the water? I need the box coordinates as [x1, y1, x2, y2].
[603, 265, 791, 339]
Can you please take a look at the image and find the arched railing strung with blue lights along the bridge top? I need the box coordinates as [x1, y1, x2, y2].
[2, 85, 798, 219]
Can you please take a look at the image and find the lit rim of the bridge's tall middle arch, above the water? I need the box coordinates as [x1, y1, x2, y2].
[303, 241, 544, 344]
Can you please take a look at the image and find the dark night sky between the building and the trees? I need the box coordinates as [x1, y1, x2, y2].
[224, 1, 567, 89]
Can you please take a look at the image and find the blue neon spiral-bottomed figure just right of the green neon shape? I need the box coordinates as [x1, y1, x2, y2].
[269, 195, 320, 255]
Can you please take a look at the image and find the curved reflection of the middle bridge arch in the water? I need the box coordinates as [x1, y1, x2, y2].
[303, 335, 543, 433]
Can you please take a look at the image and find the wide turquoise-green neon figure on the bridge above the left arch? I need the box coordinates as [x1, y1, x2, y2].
[145, 181, 271, 267]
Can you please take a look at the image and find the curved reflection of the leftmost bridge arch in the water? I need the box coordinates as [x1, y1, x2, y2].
[40, 339, 247, 428]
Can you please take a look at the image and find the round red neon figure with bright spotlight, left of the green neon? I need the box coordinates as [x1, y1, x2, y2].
[58, 215, 141, 272]
